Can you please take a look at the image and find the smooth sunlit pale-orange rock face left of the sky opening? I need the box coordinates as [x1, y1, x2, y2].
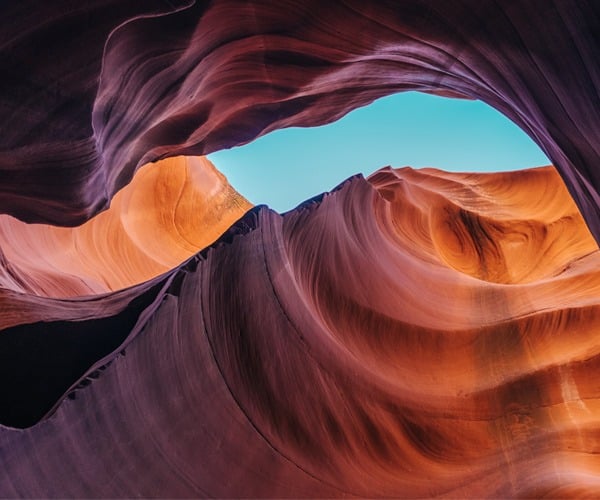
[0, 156, 252, 297]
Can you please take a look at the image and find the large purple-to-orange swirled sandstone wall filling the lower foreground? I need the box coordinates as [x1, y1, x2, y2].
[0, 167, 600, 498]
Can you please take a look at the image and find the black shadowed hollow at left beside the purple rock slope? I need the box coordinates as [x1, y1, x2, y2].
[0, 282, 163, 428]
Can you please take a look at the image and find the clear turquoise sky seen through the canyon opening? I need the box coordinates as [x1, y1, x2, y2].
[209, 92, 550, 212]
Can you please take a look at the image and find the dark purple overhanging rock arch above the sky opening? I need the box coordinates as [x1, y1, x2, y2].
[0, 0, 600, 244]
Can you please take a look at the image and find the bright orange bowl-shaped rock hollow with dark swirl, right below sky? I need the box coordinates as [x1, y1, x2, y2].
[369, 166, 598, 283]
